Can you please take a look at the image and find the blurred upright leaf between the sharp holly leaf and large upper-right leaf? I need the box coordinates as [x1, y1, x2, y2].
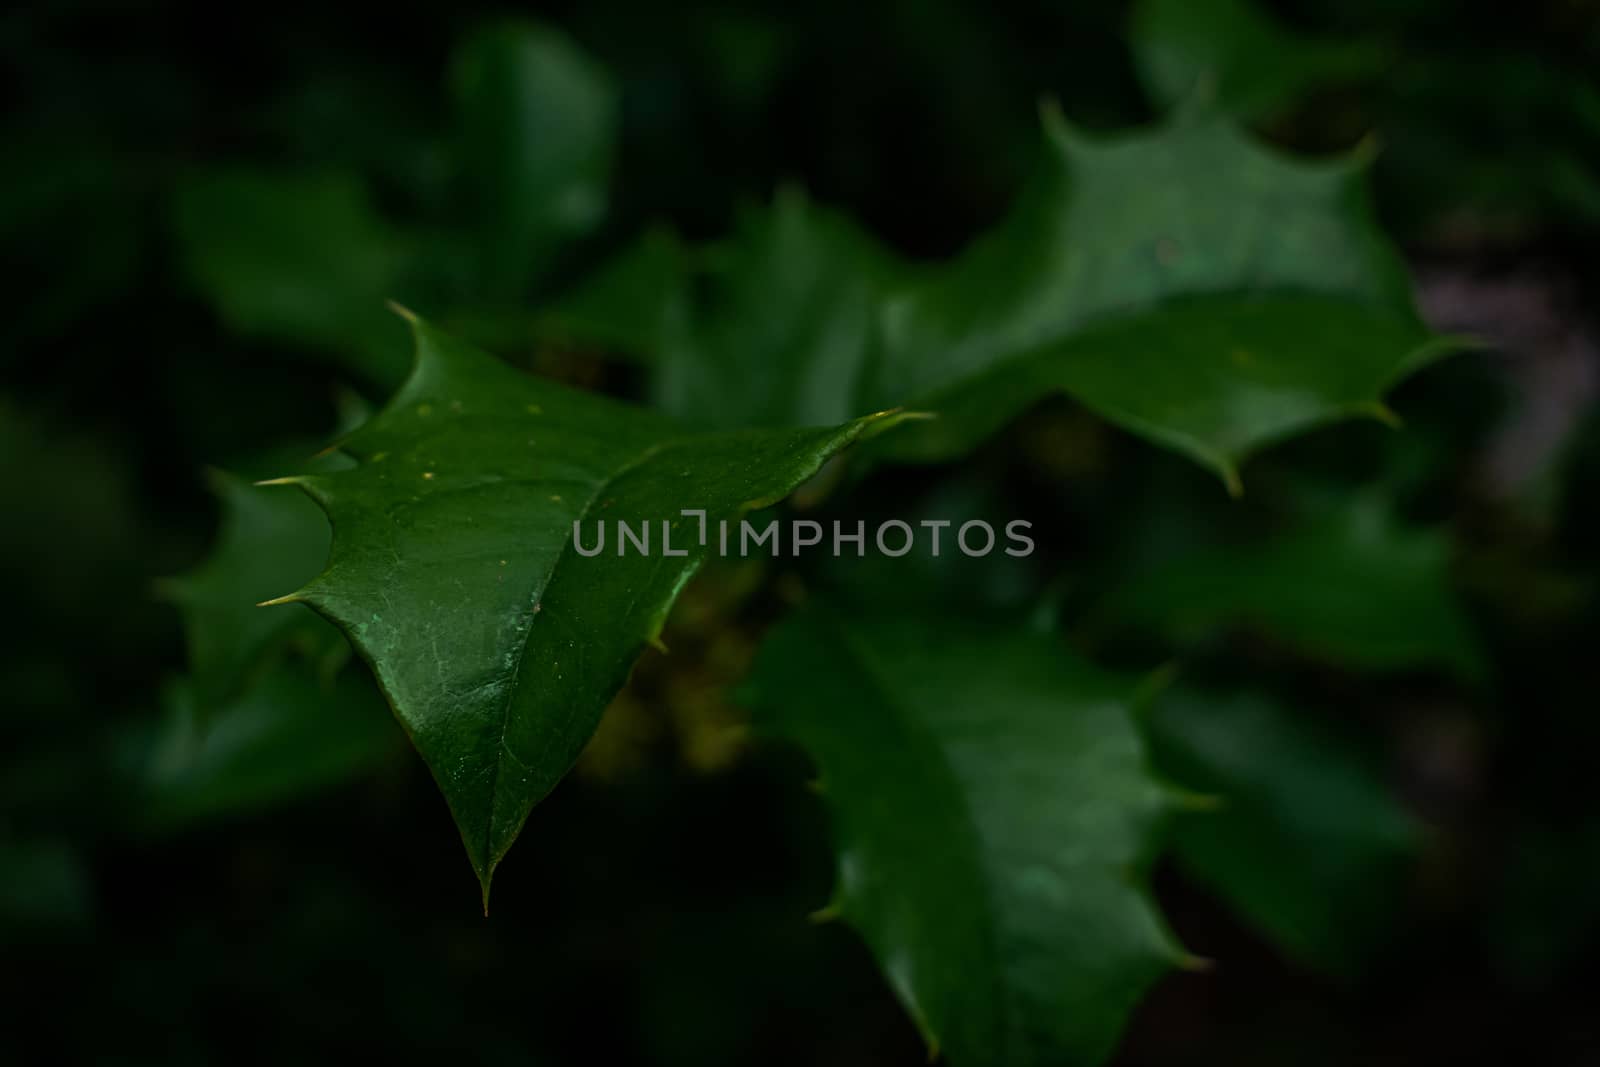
[656, 189, 901, 427]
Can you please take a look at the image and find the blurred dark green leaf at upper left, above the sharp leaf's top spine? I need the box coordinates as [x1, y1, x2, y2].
[176, 170, 406, 386]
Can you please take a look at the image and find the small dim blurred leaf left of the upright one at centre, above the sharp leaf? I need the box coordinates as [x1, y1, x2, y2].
[541, 229, 688, 363]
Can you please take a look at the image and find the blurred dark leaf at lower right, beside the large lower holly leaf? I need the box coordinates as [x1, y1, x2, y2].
[1149, 689, 1418, 974]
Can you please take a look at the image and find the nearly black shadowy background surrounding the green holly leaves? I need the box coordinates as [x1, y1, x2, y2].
[0, 0, 1600, 1067]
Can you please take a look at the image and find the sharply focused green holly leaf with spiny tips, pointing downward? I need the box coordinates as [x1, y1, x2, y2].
[264, 318, 915, 904]
